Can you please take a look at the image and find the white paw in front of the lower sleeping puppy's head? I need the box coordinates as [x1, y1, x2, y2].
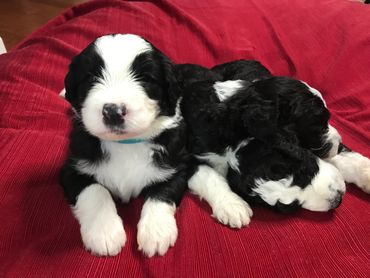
[212, 192, 253, 229]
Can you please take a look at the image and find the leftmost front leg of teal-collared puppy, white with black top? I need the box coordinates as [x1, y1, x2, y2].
[61, 163, 126, 256]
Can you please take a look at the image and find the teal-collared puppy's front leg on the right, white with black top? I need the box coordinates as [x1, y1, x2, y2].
[137, 171, 187, 257]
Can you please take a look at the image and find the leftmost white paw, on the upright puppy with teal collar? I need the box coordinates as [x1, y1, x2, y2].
[81, 214, 126, 256]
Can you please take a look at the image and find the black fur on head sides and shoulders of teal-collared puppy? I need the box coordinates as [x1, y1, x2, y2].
[60, 35, 192, 208]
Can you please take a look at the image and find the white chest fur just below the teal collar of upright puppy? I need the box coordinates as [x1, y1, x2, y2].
[76, 141, 175, 202]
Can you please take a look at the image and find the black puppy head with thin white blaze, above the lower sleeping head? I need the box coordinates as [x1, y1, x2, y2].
[254, 77, 341, 158]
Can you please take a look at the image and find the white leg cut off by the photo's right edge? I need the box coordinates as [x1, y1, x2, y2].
[327, 146, 370, 193]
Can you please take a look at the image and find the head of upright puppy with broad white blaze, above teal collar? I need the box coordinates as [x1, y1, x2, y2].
[65, 34, 179, 140]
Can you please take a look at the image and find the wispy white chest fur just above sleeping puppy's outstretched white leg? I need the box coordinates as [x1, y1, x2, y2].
[197, 139, 251, 177]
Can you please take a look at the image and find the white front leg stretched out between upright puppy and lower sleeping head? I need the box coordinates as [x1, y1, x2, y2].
[188, 165, 253, 228]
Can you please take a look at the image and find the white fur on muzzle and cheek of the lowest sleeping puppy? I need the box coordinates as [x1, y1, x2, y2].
[253, 159, 345, 211]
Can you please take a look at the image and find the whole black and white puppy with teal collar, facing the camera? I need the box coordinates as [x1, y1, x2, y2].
[61, 34, 190, 256]
